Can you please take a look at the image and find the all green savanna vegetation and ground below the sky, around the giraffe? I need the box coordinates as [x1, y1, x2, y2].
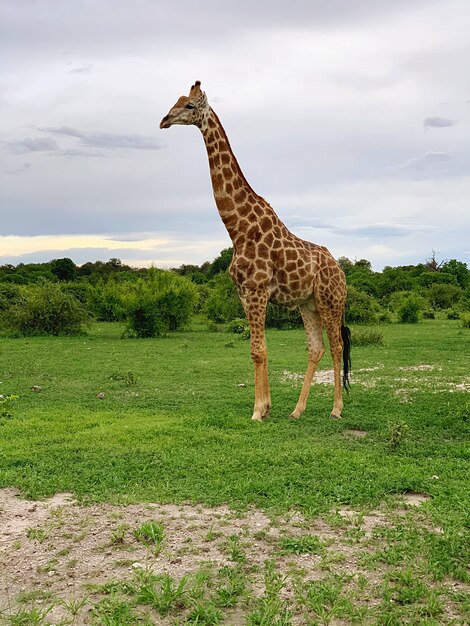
[0, 250, 470, 626]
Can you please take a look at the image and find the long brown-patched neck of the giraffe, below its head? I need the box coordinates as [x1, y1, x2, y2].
[201, 109, 278, 245]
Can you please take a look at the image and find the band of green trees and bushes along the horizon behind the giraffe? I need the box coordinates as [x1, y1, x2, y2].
[0, 248, 470, 337]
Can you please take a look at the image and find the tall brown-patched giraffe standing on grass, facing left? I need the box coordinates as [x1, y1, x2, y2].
[160, 81, 350, 421]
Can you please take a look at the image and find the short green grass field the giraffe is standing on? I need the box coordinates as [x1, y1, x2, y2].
[0, 320, 470, 626]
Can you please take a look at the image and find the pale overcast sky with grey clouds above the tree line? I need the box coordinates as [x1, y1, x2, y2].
[0, 0, 470, 271]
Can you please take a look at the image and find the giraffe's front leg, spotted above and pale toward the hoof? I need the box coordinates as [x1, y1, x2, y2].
[242, 292, 271, 422]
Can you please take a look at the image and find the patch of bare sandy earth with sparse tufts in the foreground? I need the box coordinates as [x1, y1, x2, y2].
[0, 490, 468, 626]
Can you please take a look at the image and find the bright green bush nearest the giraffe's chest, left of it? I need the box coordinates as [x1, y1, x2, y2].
[125, 269, 198, 337]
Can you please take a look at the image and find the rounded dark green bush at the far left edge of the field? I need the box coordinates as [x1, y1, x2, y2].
[5, 283, 88, 336]
